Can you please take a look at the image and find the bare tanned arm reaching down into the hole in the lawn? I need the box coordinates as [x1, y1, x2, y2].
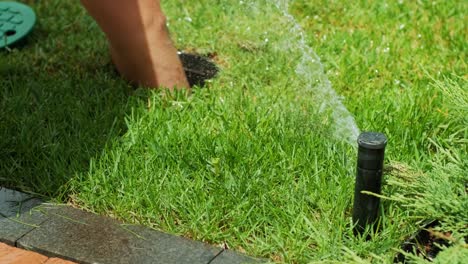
[81, 0, 189, 90]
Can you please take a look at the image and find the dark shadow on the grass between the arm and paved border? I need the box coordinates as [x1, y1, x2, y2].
[0, 55, 135, 199]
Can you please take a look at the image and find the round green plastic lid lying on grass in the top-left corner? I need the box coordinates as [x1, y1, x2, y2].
[0, 2, 36, 48]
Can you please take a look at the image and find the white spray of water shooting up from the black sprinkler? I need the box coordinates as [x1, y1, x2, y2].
[178, 0, 360, 146]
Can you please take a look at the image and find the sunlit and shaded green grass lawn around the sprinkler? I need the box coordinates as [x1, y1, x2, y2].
[0, 0, 468, 263]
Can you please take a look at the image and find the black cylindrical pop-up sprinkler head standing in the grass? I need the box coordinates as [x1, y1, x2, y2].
[353, 132, 387, 233]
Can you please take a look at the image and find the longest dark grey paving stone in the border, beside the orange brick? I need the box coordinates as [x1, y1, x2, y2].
[18, 206, 221, 264]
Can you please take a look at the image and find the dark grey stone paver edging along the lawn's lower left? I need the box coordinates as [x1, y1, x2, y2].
[0, 188, 260, 264]
